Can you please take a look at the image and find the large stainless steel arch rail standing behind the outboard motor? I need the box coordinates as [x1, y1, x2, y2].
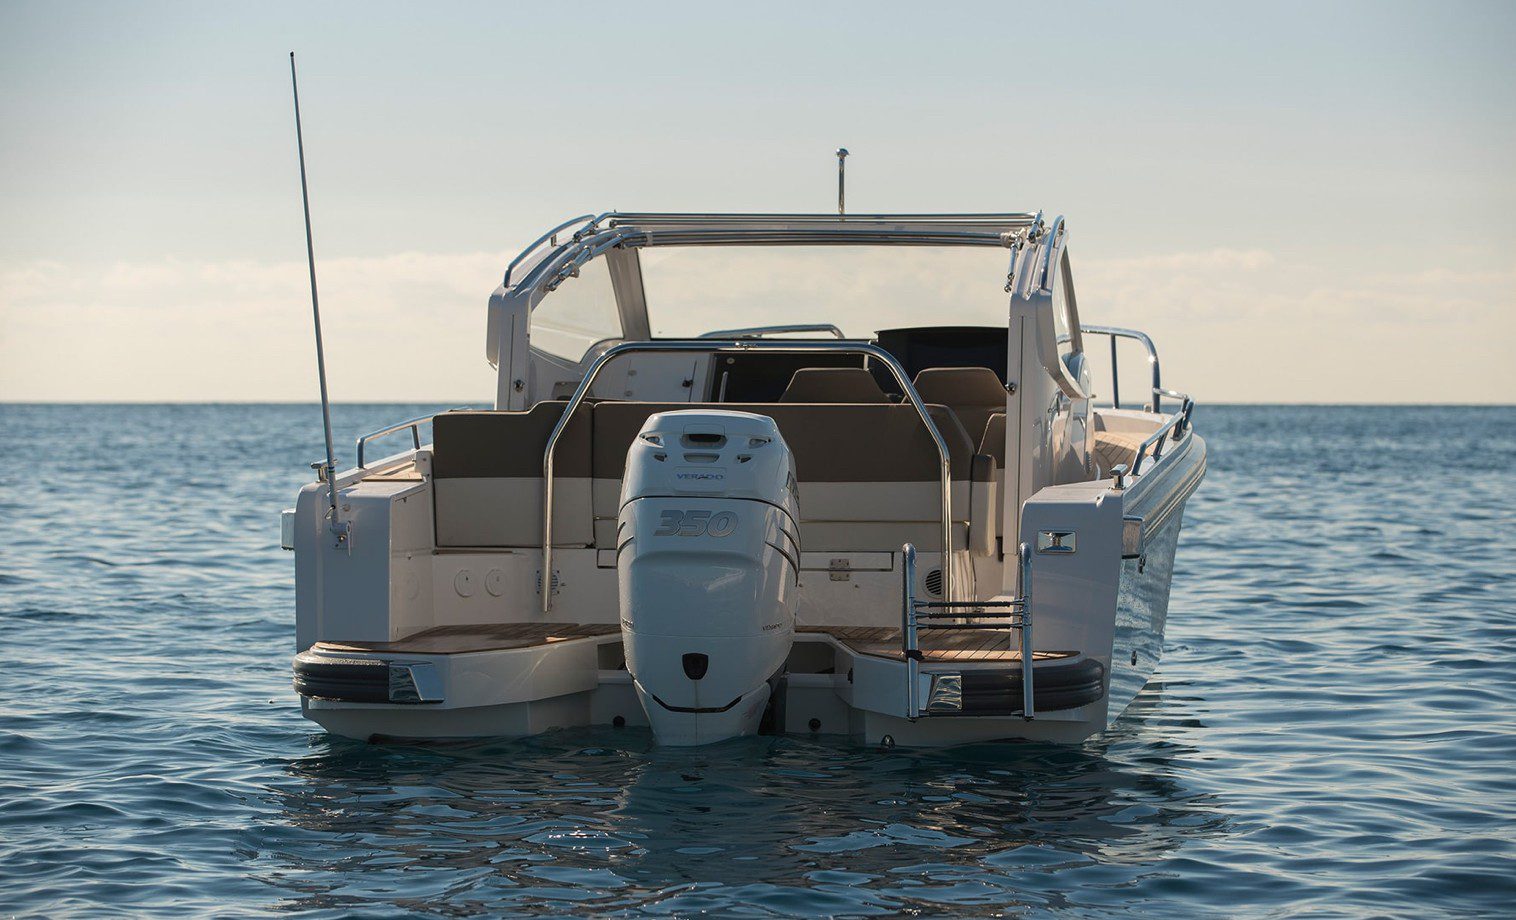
[541, 340, 954, 612]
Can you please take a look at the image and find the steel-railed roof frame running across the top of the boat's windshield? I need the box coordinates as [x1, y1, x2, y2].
[503, 211, 1066, 289]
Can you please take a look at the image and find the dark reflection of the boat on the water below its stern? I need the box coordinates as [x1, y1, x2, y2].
[264, 687, 1226, 914]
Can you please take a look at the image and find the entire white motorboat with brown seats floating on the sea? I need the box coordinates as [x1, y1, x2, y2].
[282, 208, 1205, 747]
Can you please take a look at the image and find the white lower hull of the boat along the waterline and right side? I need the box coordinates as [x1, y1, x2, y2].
[292, 421, 1205, 746]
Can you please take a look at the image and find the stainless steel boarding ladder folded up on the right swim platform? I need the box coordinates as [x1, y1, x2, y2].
[901, 543, 1037, 721]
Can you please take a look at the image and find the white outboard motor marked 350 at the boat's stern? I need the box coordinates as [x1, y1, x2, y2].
[615, 409, 800, 744]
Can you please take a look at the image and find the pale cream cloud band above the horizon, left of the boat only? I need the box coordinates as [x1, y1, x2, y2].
[0, 253, 509, 402]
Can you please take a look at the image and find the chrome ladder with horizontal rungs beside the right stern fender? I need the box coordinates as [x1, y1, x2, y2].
[901, 543, 1037, 721]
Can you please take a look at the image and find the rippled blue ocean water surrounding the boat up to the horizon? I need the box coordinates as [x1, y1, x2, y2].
[0, 405, 1516, 917]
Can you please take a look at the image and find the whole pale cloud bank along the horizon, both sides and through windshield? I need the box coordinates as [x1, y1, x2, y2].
[0, 249, 1516, 402]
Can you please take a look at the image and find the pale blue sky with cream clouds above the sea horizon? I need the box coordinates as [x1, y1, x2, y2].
[0, 0, 1516, 403]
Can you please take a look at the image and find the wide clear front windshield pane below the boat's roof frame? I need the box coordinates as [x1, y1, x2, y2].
[638, 246, 1010, 338]
